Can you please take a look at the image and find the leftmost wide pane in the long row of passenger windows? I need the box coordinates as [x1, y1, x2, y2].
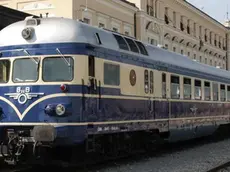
[171, 76, 180, 99]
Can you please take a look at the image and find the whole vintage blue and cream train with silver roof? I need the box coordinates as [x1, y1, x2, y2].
[0, 17, 230, 163]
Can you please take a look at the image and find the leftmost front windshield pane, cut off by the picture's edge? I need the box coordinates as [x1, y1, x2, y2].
[0, 60, 10, 83]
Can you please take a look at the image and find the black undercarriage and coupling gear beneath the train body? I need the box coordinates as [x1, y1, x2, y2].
[0, 128, 167, 165]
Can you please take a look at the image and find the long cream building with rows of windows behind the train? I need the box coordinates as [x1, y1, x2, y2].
[0, 0, 230, 70]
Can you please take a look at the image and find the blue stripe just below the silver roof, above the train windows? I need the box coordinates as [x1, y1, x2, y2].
[0, 43, 230, 84]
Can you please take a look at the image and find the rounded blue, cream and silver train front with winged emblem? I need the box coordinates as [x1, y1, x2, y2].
[0, 18, 85, 163]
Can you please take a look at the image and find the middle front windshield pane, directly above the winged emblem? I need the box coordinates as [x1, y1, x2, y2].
[13, 58, 39, 82]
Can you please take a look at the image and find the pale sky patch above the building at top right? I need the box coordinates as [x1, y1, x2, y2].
[187, 0, 230, 23]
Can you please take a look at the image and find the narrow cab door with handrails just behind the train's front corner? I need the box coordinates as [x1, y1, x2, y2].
[87, 56, 100, 121]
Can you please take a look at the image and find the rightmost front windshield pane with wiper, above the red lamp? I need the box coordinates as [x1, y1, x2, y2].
[42, 57, 74, 82]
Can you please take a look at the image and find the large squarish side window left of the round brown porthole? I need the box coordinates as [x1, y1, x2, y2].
[104, 63, 120, 86]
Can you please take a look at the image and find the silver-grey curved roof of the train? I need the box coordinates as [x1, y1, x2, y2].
[0, 18, 230, 83]
